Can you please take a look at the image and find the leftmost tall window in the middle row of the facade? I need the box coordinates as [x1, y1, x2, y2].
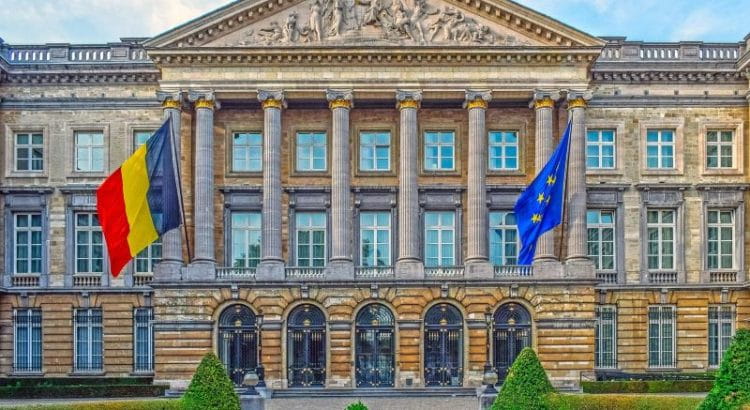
[13, 213, 43, 274]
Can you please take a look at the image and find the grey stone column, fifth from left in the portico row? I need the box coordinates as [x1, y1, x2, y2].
[396, 90, 424, 279]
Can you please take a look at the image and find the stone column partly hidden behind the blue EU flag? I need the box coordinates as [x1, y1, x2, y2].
[531, 91, 560, 261]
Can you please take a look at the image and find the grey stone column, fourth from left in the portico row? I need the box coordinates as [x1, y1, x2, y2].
[326, 90, 354, 279]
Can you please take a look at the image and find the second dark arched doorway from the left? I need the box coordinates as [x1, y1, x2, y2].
[287, 304, 326, 387]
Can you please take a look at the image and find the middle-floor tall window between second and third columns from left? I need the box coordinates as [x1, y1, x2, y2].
[231, 212, 261, 268]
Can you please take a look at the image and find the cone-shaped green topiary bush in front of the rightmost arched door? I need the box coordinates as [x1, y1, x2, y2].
[492, 347, 554, 410]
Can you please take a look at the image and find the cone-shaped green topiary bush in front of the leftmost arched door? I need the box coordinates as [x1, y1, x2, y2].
[182, 353, 240, 410]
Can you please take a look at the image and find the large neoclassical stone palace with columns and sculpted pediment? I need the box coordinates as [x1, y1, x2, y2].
[0, 0, 750, 389]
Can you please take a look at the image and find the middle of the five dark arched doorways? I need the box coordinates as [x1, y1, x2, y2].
[355, 303, 395, 387]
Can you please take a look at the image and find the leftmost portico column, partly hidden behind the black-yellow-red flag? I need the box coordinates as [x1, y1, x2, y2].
[154, 91, 184, 282]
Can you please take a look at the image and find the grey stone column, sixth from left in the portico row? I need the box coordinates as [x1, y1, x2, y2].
[464, 90, 493, 277]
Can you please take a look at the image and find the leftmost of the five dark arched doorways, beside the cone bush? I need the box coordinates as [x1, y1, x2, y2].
[218, 304, 258, 386]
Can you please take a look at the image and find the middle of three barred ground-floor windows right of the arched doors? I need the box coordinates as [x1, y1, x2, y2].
[648, 305, 677, 367]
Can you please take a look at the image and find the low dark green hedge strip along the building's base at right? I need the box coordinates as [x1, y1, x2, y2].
[581, 380, 714, 394]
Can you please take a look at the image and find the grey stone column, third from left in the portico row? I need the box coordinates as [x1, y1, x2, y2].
[257, 90, 286, 280]
